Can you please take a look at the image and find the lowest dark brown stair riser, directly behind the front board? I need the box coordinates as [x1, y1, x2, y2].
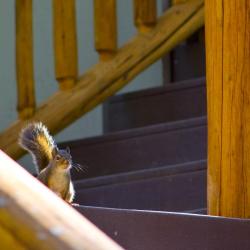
[76, 170, 206, 211]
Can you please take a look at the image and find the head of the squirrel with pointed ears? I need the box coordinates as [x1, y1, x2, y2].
[52, 147, 72, 170]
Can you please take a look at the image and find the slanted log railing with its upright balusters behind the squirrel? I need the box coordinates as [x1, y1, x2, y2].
[0, 0, 204, 159]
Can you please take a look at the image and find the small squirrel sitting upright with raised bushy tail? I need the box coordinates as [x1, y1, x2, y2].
[19, 122, 75, 203]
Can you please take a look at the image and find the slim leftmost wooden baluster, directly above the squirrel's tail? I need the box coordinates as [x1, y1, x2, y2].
[16, 0, 36, 119]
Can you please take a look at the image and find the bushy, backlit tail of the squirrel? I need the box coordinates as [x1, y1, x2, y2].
[19, 122, 57, 173]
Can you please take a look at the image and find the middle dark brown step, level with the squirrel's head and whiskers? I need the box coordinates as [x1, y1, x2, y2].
[60, 117, 207, 180]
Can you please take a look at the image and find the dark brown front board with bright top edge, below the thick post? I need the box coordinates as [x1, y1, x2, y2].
[76, 206, 250, 250]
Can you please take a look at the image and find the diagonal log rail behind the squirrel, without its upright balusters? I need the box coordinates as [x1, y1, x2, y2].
[0, 0, 204, 158]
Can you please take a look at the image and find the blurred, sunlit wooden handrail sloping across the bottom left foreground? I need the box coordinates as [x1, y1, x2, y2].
[0, 151, 122, 250]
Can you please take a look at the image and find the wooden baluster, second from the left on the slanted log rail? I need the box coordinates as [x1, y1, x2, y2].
[53, 0, 78, 90]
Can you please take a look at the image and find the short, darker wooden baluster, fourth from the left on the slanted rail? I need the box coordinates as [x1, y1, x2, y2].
[134, 0, 157, 33]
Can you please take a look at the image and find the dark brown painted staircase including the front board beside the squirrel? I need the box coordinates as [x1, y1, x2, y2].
[61, 78, 250, 250]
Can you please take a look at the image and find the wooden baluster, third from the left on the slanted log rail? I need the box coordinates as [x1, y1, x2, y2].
[94, 0, 117, 61]
